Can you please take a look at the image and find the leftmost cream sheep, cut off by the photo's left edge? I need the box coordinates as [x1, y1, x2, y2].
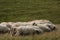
[0, 22, 13, 33]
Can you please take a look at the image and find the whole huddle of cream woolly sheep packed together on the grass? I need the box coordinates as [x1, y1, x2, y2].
[0, 20, 56, 36]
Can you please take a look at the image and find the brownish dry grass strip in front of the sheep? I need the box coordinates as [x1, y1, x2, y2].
[0, 25, 60, 40]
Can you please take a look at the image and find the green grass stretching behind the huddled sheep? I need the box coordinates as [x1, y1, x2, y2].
[0, 0, 60, 24]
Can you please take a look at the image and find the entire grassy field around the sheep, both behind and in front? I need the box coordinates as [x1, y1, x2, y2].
[0, 0, 60, 40]
